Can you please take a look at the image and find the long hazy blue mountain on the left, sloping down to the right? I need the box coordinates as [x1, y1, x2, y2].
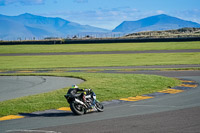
[0, 13, 108, 40]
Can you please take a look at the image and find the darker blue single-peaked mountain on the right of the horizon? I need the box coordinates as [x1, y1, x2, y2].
[113, 14, 200, 33]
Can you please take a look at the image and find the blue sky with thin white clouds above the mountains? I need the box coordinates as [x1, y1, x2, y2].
[0, 0, 200, 29]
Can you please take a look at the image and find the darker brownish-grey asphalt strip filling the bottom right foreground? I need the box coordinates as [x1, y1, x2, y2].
[40, 106, 200, 133]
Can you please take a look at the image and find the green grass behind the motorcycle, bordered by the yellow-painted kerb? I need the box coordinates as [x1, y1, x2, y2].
[0, 73, 180, 116]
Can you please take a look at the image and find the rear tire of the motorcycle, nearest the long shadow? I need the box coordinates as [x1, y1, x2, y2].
[70, 102, 85, 115]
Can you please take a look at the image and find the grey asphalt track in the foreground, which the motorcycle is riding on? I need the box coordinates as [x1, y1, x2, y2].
[0, 71, 200, 133]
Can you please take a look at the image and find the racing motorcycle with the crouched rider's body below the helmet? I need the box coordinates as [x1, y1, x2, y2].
[65, 89, 104, 115]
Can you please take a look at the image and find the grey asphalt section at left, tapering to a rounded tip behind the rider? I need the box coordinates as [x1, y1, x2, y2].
[0, 76, 83, 101]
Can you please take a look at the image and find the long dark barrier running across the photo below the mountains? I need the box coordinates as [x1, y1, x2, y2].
[0, 37, 200, 45]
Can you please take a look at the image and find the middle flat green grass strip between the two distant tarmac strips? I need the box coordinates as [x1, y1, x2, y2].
[0, 53, 200, 70]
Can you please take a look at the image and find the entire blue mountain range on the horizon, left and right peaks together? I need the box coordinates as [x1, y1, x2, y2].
[0, 13, 200, 40]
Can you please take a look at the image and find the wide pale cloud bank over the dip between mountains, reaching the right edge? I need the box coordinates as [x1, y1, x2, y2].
[40, 7, 200, 29]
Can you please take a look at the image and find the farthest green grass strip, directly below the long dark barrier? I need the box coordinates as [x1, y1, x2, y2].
[0, 41, 200, 54]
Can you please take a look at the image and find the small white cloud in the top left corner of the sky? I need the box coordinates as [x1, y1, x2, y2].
[0, 0, 45, 6]
